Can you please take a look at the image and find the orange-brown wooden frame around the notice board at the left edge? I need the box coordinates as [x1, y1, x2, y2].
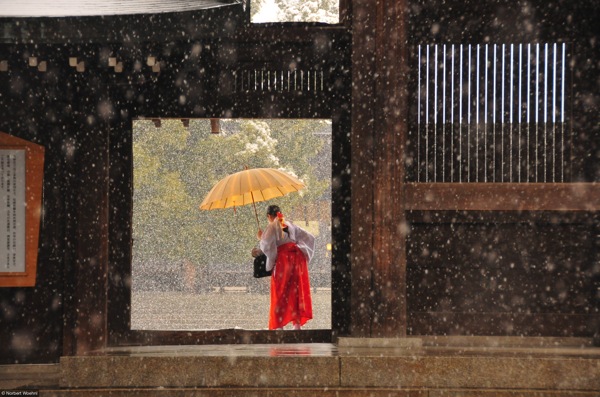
[0, 132, 44, 287]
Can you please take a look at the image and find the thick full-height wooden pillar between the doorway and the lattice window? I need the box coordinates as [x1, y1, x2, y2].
[351, 0, 407, 337]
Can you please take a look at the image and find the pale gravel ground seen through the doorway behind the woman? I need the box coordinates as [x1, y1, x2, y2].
[131, 288, 331, 330]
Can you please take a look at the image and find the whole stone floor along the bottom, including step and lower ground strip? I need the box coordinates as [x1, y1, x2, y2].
[0, 337, 600, 397]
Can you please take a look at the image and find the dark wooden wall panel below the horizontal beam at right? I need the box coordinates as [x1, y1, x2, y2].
[406, 220, 599, 337]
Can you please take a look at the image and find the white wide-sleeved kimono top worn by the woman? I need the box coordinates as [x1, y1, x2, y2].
[260, 219, 315, 271]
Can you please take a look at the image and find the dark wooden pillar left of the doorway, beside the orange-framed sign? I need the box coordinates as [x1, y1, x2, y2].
[63, 73, 109, 355]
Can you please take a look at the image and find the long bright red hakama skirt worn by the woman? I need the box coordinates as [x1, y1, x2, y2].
[269, 243, 312, 329]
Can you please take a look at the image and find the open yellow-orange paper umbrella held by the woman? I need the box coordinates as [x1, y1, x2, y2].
[200, 168, 306, 228]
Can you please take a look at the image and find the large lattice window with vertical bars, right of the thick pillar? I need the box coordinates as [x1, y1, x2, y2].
[409, 43, 572, 183]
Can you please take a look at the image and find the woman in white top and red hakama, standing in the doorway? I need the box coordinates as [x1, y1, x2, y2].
[258, 205, 315, 329]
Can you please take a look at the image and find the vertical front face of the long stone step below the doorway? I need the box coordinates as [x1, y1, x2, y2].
[60, 354, 600, 391]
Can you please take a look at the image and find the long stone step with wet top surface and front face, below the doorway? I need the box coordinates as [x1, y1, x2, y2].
[55, 338, 600, 392]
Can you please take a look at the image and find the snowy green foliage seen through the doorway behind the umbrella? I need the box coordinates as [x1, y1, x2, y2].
[133, 116, 331, 266]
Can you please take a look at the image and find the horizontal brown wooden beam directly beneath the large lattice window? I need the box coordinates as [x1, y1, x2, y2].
[405, 183, 600, 211]
